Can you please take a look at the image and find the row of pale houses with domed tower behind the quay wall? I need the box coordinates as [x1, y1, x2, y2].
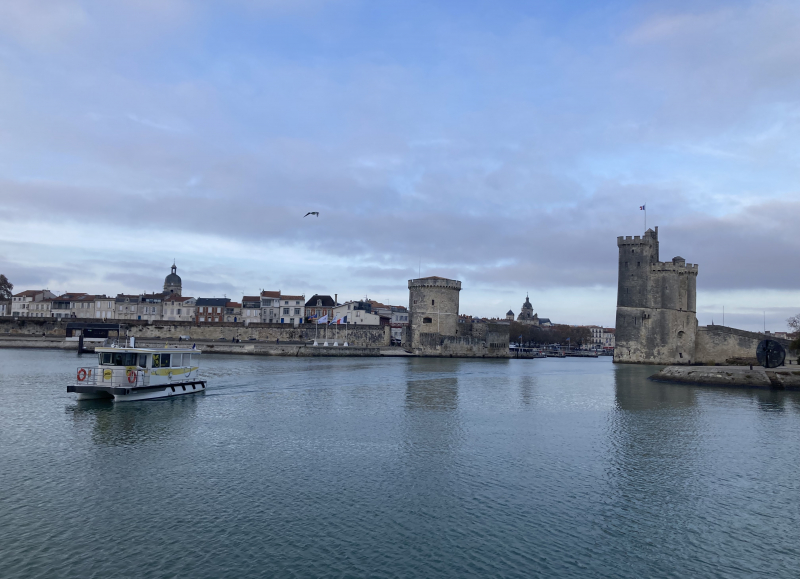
[6, 265, 416, 340]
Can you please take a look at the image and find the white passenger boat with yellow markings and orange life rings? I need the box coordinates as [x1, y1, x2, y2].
[67, 346, 206, 402]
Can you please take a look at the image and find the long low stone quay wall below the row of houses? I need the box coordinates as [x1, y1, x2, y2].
[0, 318, 391, 348]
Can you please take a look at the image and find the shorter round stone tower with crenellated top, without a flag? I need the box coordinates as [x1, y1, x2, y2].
[408, 276, 461, 348]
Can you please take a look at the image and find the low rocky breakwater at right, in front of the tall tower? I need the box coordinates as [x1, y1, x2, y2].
[650, 364, 800, 390]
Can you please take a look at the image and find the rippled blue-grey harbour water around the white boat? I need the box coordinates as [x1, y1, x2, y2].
[0, 350, 800, 578]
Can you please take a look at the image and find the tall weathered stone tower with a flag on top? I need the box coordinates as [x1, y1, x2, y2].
[614, 227, 697, 364]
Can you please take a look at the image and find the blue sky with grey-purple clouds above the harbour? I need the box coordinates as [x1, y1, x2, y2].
[0, 0, 800, 331]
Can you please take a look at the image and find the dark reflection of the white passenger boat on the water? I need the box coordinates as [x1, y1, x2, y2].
[65, 392, 205, 446]
